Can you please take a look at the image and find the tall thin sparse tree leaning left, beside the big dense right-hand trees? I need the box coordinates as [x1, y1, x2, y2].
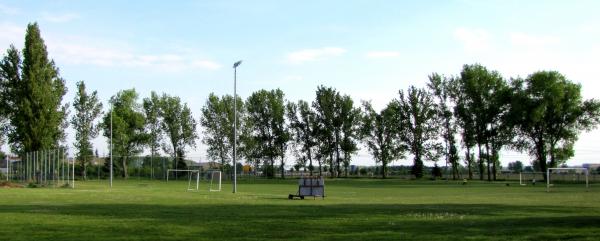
[427, 73, 460, 179]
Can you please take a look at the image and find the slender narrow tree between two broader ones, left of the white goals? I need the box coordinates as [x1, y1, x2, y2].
[142, 91, 166, 178]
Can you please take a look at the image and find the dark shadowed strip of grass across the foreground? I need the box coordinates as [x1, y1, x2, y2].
[0, 203, 600, 240]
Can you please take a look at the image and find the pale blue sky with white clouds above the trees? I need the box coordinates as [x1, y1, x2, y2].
[0, 0, 600, 168]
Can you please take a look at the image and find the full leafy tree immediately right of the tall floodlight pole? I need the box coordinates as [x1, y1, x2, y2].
[246, 89, 290, 178]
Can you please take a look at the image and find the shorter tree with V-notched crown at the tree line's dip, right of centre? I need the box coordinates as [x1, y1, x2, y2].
[360, 101, 407, 178]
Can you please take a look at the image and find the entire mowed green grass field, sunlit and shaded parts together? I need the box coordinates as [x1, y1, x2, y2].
[0, 179, 600, 240]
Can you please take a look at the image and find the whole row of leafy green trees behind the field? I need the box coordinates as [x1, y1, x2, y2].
[0, 23, 600, 180]
